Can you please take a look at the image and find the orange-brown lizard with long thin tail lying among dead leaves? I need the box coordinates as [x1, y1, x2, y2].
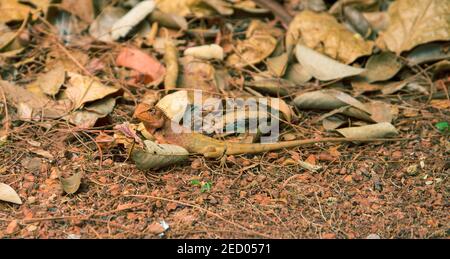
[134, 104, 404, 158]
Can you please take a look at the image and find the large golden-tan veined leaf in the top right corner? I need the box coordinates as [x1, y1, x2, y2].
[377, 0, 450, 54]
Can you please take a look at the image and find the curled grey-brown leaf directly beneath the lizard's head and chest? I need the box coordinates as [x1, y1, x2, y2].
[131, 140, 189, 170]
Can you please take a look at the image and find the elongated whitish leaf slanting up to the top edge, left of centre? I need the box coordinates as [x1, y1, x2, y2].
[111, 0, 155, 40]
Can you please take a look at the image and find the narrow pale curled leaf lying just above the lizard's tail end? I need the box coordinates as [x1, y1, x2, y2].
[337, 122, 398, 139]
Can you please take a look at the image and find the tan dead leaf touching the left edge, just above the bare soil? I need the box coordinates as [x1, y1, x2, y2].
[0, 81, 72, 120]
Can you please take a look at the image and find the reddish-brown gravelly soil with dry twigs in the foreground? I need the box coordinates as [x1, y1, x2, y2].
[0, 99, 450, 238]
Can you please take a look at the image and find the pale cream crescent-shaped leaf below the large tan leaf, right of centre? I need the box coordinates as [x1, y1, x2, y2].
[295, 44, 365, 81]
